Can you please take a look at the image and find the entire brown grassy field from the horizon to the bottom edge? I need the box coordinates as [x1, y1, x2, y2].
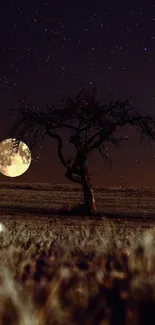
[0, 183, 155, 325]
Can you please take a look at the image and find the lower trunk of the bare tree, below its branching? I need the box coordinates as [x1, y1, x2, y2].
[82, 175, 96, 215]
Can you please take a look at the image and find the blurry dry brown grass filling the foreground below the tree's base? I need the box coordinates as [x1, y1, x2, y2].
[0, 216, 155, 325]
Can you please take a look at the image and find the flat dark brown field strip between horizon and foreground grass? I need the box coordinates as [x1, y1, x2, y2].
[0, 183, 155, 218]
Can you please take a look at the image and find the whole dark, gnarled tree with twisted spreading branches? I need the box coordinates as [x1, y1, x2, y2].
[11, 87, 155, 215]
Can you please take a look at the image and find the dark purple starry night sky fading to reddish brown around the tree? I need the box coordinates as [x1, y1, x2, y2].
[0, 0, 155, 187]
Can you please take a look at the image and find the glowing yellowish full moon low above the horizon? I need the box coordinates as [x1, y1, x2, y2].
[0, 138, 31, 177]
